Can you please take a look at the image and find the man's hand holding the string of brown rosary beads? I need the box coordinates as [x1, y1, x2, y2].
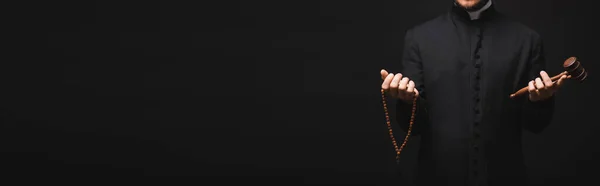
[381, 70, 419, 103]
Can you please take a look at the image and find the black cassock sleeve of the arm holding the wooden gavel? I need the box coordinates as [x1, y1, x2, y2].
[521, 34, 555, 134]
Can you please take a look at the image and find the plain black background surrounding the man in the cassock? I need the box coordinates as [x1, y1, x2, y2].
[0, 0, 600, 185]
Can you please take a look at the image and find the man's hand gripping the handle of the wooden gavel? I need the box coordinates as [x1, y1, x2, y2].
[529, 71, 568, 102]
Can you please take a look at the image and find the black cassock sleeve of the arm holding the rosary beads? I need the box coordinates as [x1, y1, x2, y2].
[396, 29, 428, 136]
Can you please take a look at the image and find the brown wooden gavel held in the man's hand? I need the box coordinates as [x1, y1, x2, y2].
[510, 57, 587, 98]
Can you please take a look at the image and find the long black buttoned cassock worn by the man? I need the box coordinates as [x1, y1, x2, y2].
[397, 1, 554, 185]
